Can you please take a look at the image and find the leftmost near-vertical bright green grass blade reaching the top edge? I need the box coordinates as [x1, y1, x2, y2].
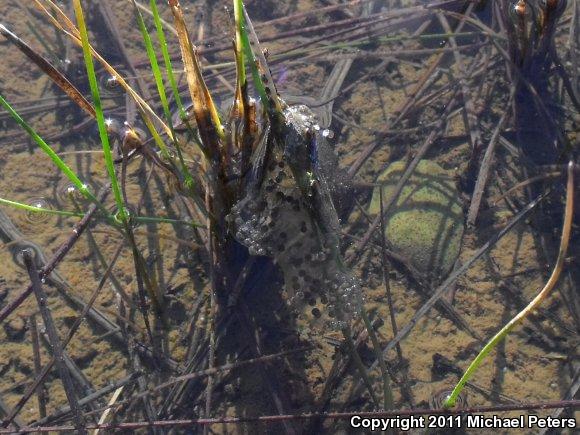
[73, 0, 127, 221]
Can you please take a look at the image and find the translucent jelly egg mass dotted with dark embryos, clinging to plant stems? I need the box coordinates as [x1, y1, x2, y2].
[229, 100, 362, 329]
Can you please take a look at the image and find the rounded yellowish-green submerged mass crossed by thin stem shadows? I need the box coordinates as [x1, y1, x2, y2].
[369, 160, 464, 280]
